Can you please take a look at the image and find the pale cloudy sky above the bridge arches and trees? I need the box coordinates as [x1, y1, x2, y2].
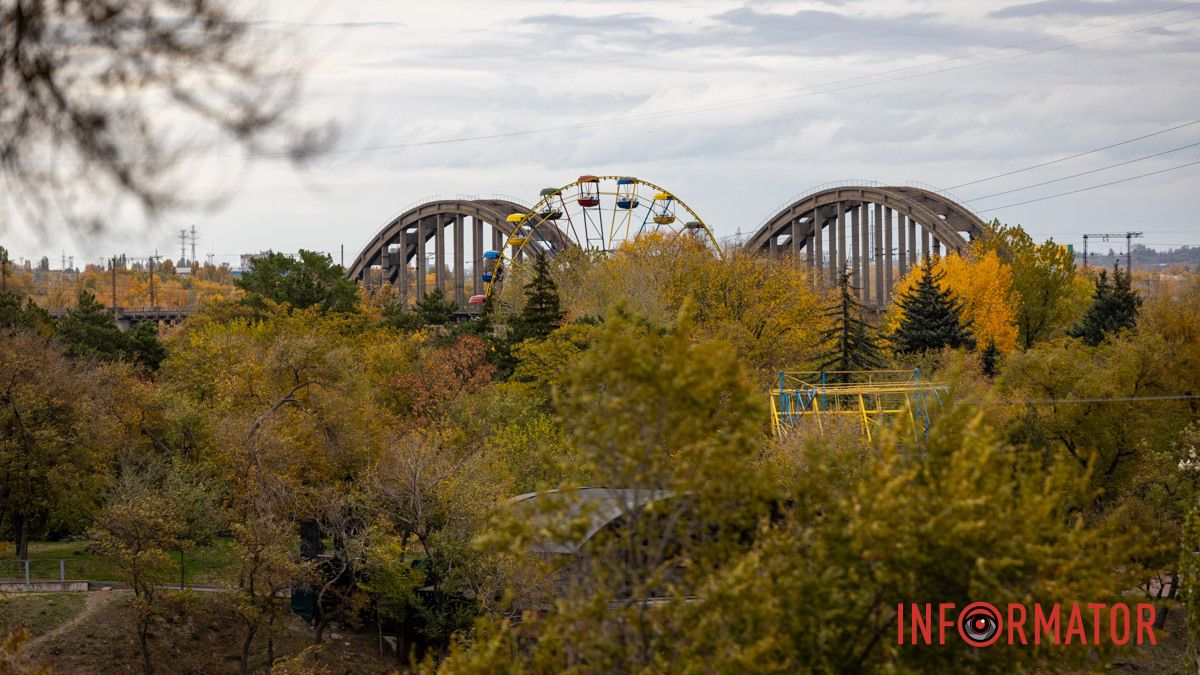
[2, 0, 1200, 267]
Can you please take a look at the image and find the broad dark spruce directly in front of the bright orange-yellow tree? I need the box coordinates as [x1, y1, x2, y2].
[888, 256, 976, 354]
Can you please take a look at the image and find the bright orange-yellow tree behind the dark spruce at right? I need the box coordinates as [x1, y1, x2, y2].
[884, 251, 1018, 354]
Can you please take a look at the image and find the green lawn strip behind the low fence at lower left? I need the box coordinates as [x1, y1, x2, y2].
[0, 539, 238, 584]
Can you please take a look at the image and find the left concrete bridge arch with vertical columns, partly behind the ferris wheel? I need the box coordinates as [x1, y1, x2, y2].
[347, 198, 565, 306]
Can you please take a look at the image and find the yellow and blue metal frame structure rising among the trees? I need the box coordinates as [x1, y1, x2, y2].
[770, 370, 947, 441]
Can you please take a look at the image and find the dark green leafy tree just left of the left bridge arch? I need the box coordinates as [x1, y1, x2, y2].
[236, 249, 358, 312]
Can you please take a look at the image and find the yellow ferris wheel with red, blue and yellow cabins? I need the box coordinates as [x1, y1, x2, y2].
[470, 175, 720, 304]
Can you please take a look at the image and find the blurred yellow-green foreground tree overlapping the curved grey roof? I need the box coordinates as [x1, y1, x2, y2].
[449, 306, 766, 671]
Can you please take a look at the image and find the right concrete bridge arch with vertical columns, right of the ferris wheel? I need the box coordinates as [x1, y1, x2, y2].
[746, 184, 985, 306]
